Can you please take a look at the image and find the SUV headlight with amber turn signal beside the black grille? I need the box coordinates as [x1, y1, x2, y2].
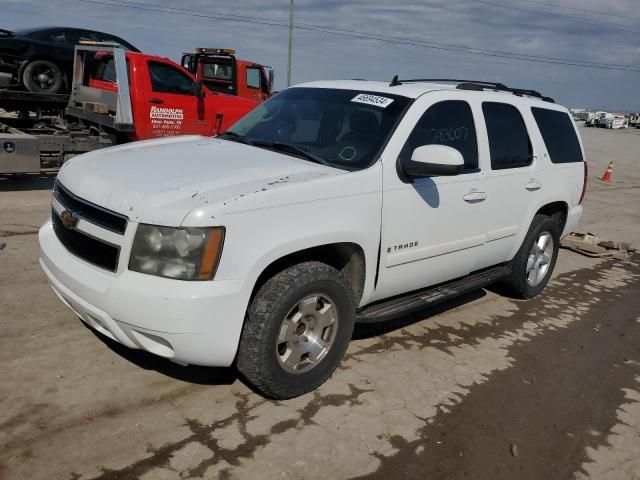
[129, 223, 224, 280]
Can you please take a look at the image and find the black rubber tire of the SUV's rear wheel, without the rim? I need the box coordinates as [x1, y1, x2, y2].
[505, 214, 560, 298]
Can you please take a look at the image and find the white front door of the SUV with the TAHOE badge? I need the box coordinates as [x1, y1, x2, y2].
[375, 92, 486, 299]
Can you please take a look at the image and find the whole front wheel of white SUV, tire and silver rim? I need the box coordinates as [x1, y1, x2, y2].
[237, 262, 356, 400]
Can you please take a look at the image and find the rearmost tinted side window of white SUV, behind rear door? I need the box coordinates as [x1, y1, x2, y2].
[531, 107, 583, 163]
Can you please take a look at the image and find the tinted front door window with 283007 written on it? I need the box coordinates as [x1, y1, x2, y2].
[400, 100, 478, 170]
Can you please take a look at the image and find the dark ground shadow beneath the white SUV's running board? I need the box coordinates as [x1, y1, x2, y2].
[351, 288, 487, 340]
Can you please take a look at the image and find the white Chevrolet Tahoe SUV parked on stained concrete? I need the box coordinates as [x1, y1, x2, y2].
[40, 79, 586, 399]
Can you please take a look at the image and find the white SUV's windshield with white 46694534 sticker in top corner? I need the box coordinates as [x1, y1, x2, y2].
[222, 87, 410, 170]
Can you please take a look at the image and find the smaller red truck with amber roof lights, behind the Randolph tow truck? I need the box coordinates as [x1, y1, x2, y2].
[180, 48, 273, 103]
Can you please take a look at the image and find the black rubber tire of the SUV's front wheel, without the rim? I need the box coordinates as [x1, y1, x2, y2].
[237, 262, 356, 400]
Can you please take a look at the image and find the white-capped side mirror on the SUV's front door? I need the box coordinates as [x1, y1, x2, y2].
[402, 145, 464, 178]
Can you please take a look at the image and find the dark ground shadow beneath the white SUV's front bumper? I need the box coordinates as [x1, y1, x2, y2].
[81, 322, 238, 385]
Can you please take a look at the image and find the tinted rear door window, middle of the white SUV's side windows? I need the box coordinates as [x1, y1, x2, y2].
[482, 102, 533, 170]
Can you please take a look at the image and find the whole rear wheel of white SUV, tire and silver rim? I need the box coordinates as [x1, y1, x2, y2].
[506, 214, 560, 298]
